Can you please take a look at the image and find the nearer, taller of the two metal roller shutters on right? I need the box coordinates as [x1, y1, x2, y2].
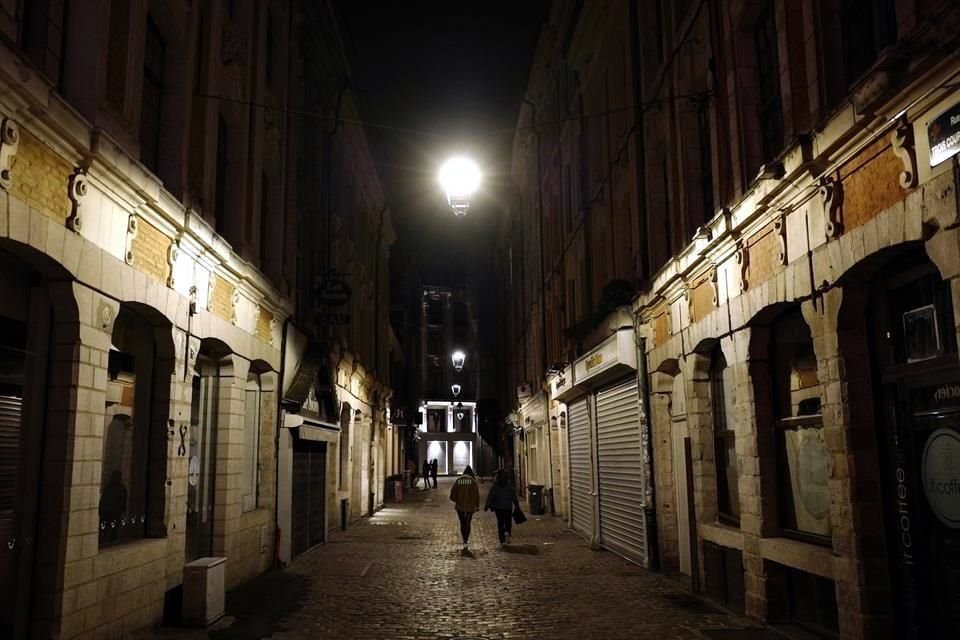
[597, 378, 647, 566]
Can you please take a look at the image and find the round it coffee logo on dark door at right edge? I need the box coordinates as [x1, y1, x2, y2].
[920, 427, 960, 529]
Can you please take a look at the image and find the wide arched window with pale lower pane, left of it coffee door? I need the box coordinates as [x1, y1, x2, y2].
[770, 307, 831, 544]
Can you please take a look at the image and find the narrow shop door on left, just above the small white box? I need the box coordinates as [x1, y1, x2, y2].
[186, 371, 219, 562]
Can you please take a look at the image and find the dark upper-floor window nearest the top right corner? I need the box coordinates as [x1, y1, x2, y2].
[840, 0, 897, 86]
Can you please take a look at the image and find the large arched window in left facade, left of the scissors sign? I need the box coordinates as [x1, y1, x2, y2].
[98, 307, 156, 547]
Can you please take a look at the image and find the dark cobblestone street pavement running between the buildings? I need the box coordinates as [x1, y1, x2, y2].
[148, 480, 766, 640]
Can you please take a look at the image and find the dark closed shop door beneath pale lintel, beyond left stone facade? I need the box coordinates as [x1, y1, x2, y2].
[290, 438, 327, 558]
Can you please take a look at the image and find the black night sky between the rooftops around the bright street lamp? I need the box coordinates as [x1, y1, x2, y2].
[335, 0, 549, 287]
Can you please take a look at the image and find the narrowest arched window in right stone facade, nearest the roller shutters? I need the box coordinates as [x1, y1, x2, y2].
[710, 344, 740, 526]
